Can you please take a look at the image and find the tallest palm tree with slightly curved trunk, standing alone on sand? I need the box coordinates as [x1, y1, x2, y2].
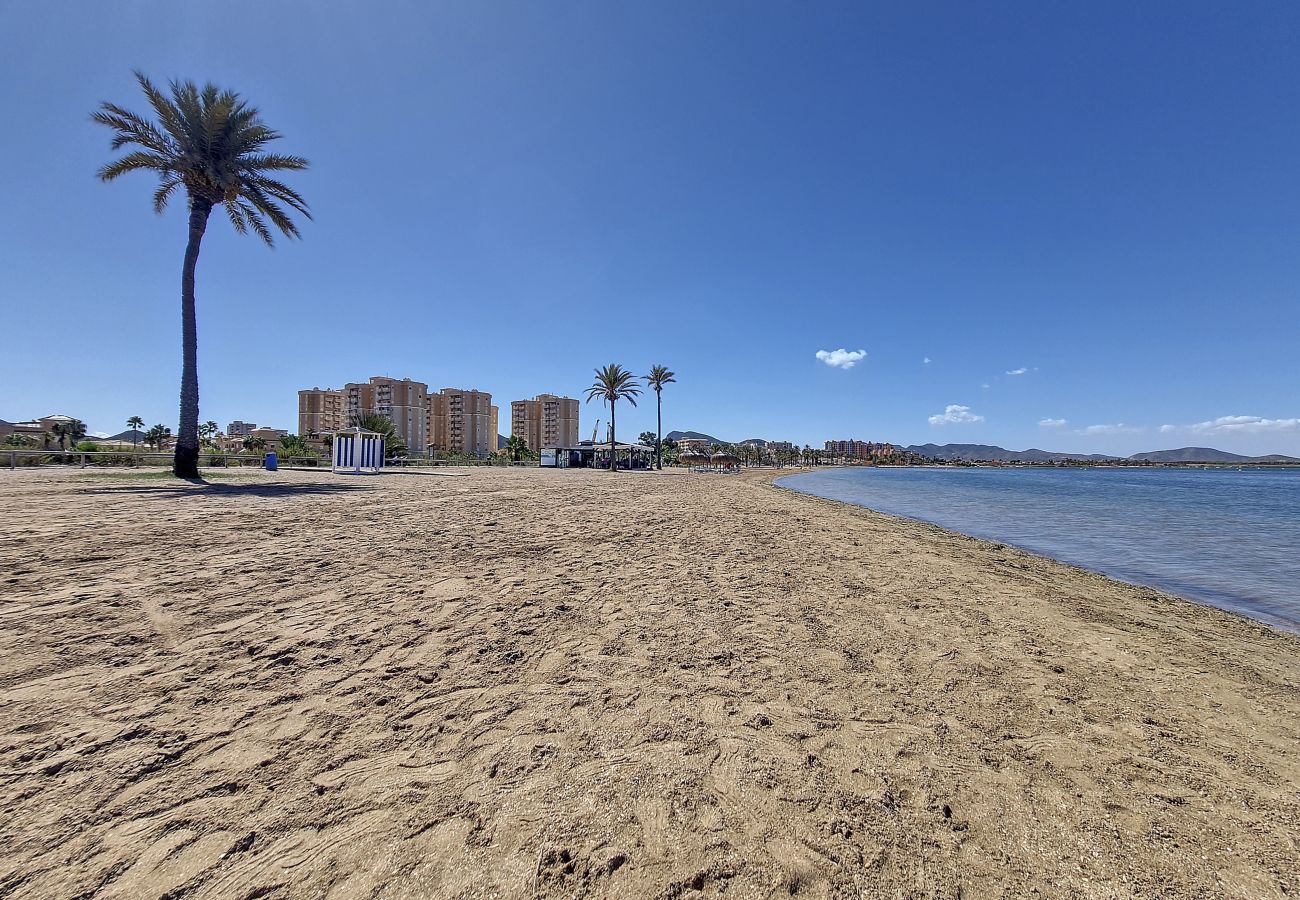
[92, 72, 311, 479]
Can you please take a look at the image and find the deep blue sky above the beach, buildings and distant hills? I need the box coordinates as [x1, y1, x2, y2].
[0, 0, 1300, 455]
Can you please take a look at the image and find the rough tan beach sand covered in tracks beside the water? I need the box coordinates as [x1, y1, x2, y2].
[0, 470, 1300, 899]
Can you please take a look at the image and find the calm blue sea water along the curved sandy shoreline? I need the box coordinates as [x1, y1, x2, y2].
[780, 468, 1300, 632]
